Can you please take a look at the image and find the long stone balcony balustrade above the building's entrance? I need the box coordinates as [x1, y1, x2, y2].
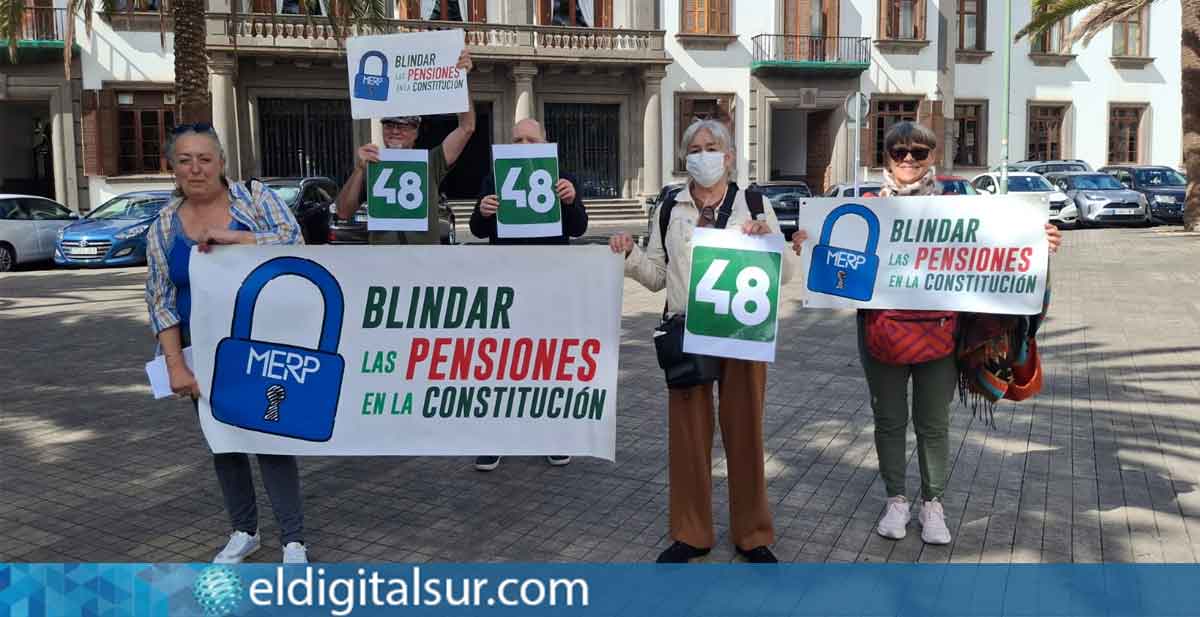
[208, 13, 668, 62]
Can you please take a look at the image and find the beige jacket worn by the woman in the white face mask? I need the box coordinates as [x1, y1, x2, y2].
[625, 187, 796, 313]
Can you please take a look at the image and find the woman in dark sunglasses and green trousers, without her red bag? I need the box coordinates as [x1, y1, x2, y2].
[858, 122, 1062, 544]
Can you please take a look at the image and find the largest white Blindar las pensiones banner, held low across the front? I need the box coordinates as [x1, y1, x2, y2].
[190, 246, 623, 460]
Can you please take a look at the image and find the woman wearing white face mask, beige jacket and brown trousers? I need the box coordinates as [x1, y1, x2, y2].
[608, 120, 804, 563]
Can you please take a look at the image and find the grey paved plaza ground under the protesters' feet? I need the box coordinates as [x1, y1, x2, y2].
[0, 227, 1200, 563]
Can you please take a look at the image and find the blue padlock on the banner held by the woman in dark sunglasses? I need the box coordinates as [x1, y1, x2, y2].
[809, 204, 880, 302]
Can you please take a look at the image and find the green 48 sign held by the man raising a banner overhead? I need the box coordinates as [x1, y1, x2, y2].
[367, 149, 430, 232]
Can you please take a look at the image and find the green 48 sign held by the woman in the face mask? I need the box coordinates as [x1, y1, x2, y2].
[683, 228, 784, 363]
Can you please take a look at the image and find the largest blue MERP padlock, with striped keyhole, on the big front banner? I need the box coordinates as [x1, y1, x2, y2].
[211, 257, 346, 442]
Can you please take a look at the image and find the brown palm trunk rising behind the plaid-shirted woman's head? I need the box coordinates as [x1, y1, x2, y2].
[172, 0, 212, 124]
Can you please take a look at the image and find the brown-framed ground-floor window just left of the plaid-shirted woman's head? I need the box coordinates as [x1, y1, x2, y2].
[116, 92, 175, 175]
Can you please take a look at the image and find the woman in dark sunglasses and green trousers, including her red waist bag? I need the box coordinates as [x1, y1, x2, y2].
[840, 122, 1062, 544]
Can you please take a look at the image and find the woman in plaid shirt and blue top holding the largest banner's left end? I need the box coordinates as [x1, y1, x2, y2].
[146, 124, 307, 563]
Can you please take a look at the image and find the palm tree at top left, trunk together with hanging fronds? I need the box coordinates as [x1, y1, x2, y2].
[0, 0, 388, 122]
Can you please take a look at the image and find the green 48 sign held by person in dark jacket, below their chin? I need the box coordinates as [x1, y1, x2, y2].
[492, 144, 563, 238]
